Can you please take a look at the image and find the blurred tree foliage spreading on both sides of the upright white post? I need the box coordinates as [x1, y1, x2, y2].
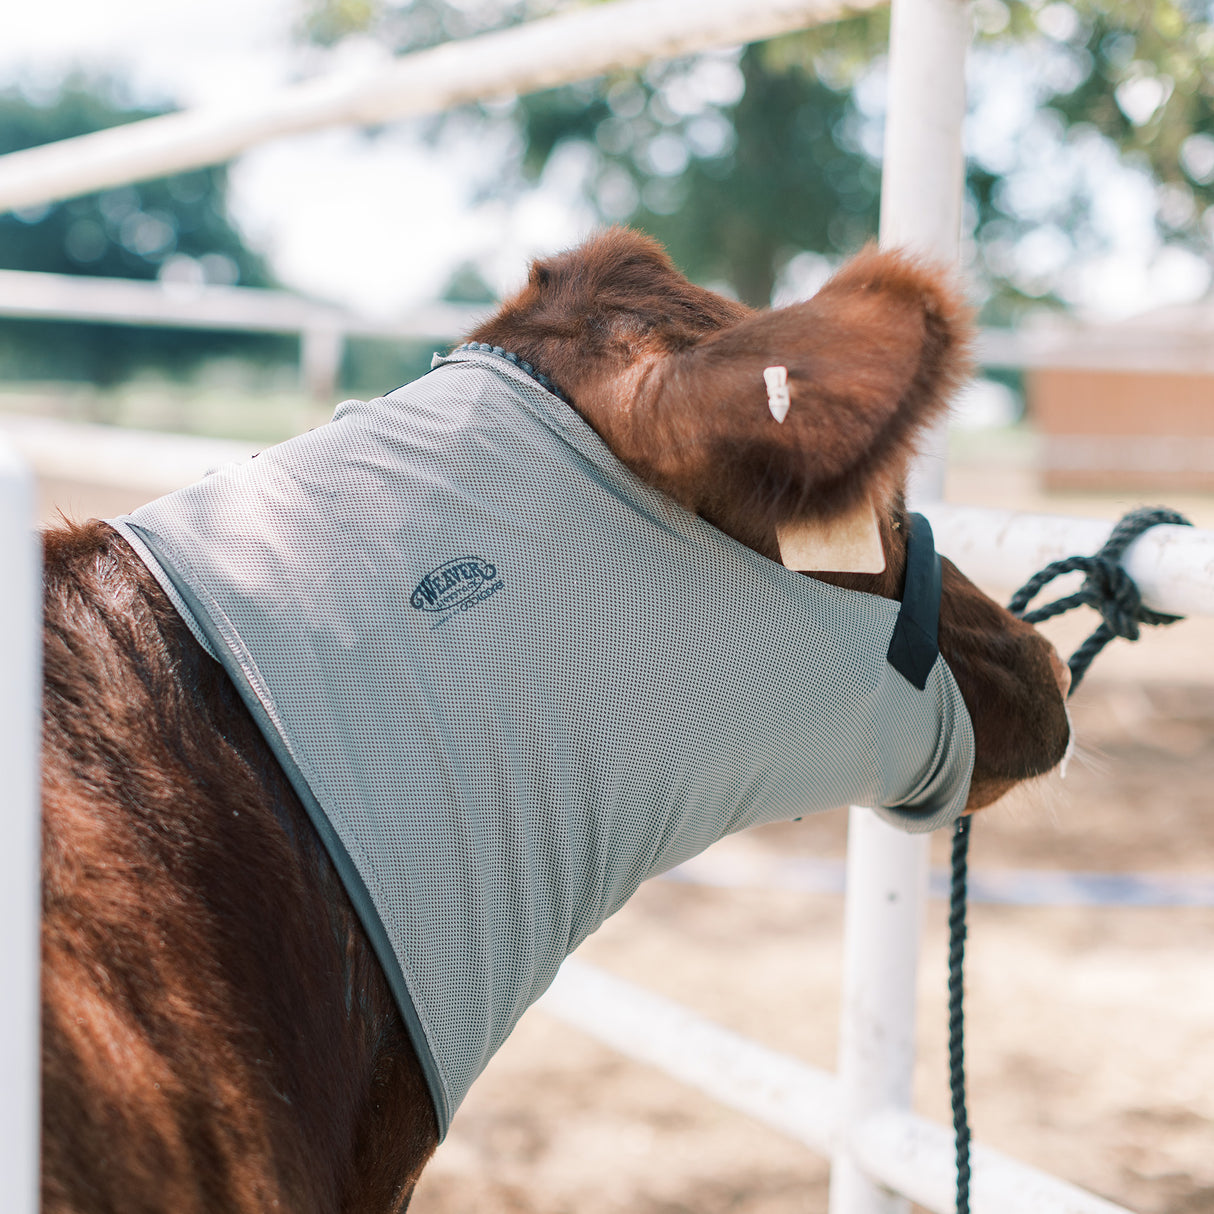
[301, 0, 1214, 320]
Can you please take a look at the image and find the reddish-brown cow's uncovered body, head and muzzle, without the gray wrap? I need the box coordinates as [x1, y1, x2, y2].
[42, 229, 1068, 1214]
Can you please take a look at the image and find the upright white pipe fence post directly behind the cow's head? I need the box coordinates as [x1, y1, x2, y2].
[830, 0, 970, 1214]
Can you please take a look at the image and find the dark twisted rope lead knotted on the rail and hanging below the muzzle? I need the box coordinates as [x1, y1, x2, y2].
[948, 507, 1192, 1214]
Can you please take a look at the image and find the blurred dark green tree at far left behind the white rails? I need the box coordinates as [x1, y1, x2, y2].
[0, 80, 296, 384]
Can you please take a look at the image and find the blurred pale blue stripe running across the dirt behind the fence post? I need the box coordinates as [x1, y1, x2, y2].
[665, 857, 1214, 907]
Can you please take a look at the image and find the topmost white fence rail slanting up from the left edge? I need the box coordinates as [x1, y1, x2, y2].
[0, 0, 887, 211]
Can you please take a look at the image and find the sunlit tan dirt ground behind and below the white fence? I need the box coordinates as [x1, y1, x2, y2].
[16, 407, 1214, 1214]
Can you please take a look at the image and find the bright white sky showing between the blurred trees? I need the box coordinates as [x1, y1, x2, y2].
[0, 0, 1209, 318]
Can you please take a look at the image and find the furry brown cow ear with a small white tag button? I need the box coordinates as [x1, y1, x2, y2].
[605, 249, 970, 548]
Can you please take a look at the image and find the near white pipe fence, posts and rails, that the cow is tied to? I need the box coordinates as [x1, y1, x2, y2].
[0, 0, 1199, 1214]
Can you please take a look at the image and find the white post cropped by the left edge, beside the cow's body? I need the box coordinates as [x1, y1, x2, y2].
[0, 439, 41, 1214]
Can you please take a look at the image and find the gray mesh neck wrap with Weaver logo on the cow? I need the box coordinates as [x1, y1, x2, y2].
[114, 351, 974, 1133]
